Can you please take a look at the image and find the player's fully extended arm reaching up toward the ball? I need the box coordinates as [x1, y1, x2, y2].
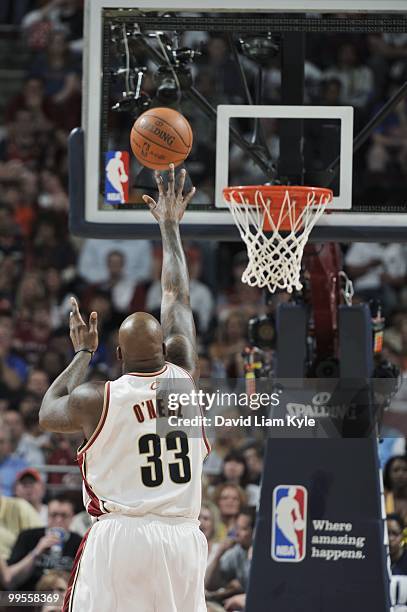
[143, 164, 198, 379]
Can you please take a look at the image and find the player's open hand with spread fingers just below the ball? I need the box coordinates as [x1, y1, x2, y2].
[143, 164, 195, 223]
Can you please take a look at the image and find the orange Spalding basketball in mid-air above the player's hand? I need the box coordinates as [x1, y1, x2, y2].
[130, 108, 193, 170]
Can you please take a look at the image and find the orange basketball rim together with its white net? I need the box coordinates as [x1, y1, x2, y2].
[223, 185, 333, 293]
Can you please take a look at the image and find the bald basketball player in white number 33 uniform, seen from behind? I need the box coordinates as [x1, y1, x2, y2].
[40, 165, 209, 612]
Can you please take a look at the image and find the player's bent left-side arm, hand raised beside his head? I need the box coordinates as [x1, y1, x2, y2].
[39, 298, 103, 433]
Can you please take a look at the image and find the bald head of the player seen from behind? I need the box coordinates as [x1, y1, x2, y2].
[117, 312, 165, 372]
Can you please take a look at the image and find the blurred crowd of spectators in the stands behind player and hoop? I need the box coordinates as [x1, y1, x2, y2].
[0, 0, 407, 612]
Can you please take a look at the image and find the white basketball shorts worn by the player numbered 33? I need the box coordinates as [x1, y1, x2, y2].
[63, 513, 208, 612]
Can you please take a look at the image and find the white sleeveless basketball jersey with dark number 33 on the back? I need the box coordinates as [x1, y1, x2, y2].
[78, 363, 210, 519]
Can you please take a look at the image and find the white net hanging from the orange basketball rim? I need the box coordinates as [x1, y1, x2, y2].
[226, 189, 330, 293]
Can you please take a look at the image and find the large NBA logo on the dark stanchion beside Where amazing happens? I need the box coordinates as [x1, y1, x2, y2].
[271, 485, 307, 562]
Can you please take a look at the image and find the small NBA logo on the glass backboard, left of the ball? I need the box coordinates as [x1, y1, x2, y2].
[105, 151, 130, 204]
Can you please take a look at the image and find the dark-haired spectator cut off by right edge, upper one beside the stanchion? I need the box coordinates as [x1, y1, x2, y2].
[383, 455, 407, 525]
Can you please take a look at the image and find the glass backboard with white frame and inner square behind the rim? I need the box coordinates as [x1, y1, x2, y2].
[70, 0, 407, 241]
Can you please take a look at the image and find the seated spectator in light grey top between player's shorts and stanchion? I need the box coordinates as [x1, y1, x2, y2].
[205, 509, 254, 604]
